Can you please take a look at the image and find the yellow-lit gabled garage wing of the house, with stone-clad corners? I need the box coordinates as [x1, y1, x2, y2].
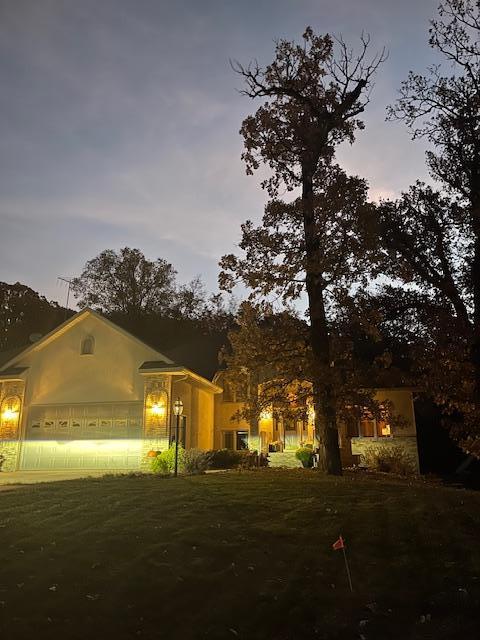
[0, 309, 221, 471]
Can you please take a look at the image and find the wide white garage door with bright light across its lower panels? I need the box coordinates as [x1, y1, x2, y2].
[21, 402, 143, 470]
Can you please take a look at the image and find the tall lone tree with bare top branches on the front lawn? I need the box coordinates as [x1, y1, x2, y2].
[220, 27, 384, 474]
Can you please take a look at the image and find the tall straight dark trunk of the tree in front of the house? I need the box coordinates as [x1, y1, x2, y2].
[302, 163, 342, 475]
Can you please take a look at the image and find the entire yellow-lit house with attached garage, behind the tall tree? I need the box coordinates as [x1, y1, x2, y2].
[0, 309, 418, 471]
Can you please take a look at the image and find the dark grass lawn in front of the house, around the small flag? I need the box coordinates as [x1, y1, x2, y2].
[0, 469, 480, 640]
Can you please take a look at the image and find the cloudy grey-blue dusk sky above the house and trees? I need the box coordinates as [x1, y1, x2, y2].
[0, 0, 438, 303]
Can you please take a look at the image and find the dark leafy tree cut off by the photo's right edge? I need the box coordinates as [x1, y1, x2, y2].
[376, 0, 480, 455]
